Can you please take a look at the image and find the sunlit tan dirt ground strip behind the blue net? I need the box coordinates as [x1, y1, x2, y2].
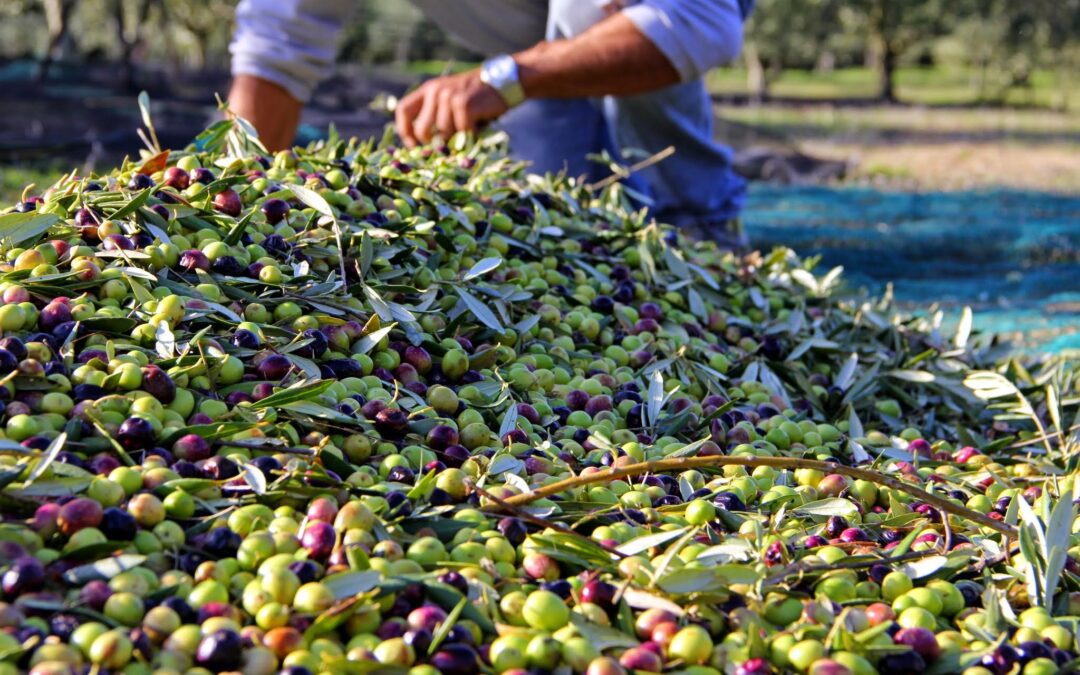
[717, 103, 1080, 193]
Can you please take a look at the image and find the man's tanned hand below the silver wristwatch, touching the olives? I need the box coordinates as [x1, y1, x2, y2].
[394, 68, 508, 148]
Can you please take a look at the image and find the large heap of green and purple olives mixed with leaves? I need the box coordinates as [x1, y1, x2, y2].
[0, 115, 1080, 675]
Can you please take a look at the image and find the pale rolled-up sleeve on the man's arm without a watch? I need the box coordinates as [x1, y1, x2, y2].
[229, 0, 355, 102]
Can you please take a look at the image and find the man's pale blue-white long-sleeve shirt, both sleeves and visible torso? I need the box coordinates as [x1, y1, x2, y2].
[230, 0, 752, 102]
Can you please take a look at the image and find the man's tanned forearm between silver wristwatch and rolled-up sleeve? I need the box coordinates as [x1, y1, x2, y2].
[514, 14, 679, 98]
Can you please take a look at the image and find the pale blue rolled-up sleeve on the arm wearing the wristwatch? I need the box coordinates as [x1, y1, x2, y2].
[623, 0, 743, 82]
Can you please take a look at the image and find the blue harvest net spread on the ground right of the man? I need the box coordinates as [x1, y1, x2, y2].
[744, 185, 1080, 352]
